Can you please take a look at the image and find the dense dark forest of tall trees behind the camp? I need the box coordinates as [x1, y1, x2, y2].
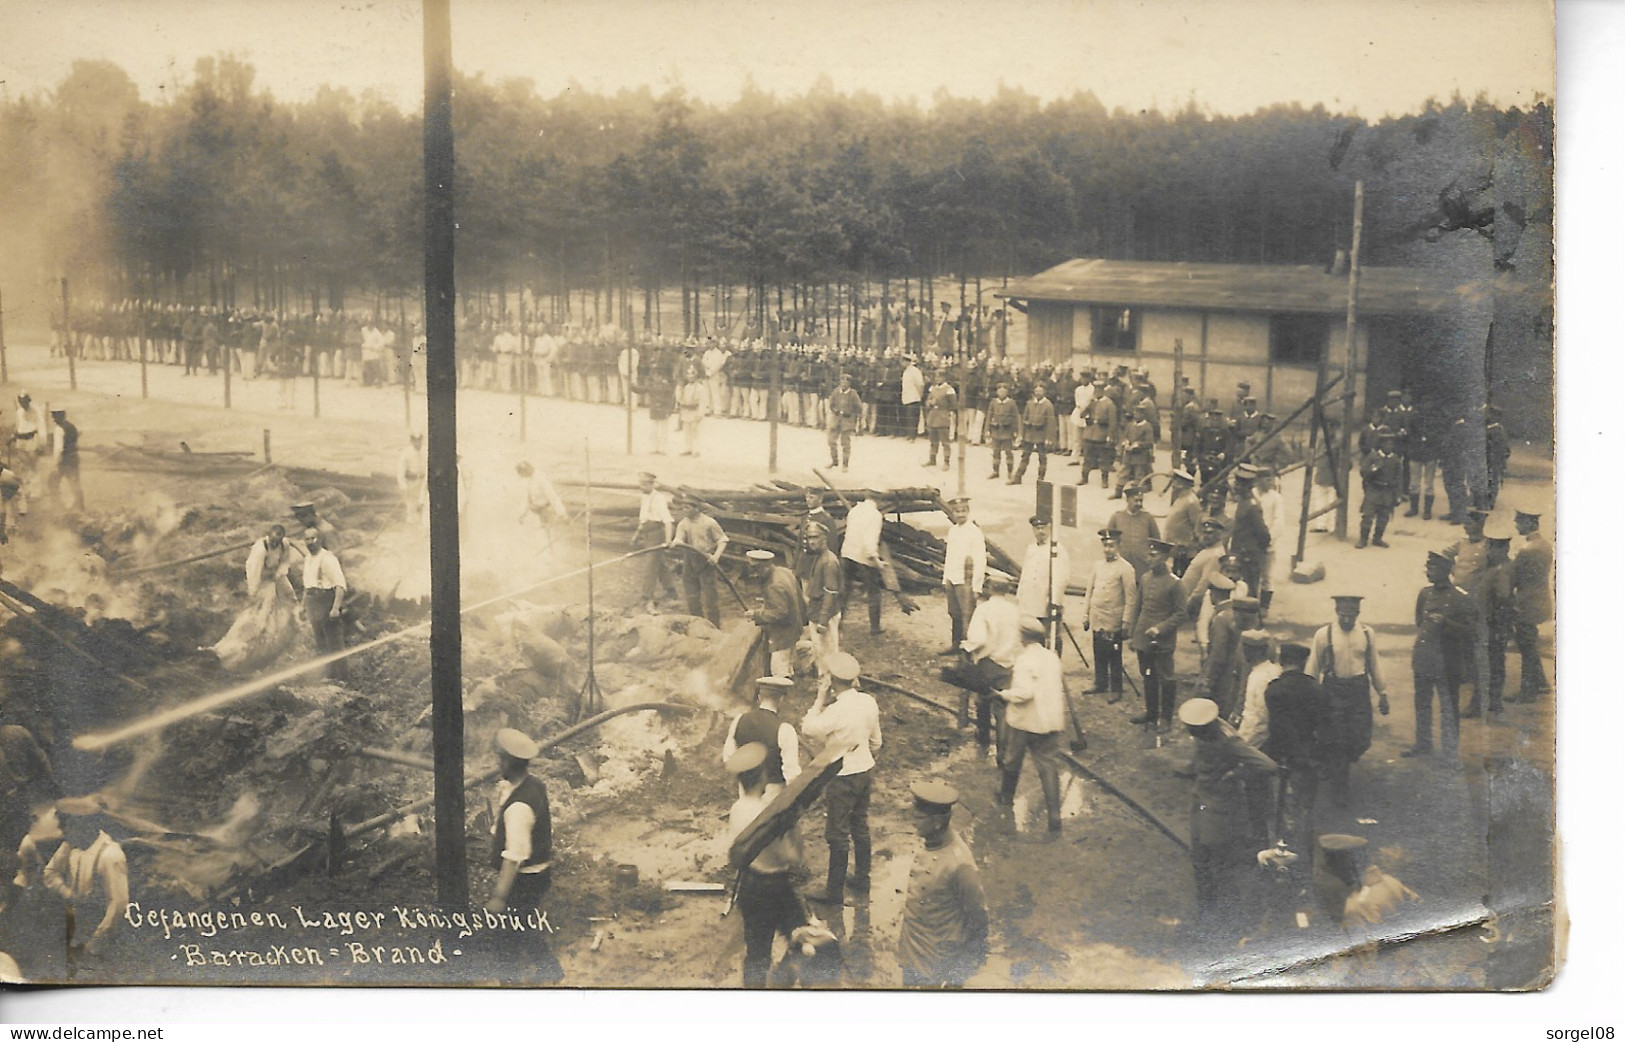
[0, 55, 1554, 339]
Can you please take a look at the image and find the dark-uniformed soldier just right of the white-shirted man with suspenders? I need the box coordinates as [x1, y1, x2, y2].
[1399, 551, 1477, 762]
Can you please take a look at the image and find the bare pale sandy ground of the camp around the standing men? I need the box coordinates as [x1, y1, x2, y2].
[8, 346, 1554, 988]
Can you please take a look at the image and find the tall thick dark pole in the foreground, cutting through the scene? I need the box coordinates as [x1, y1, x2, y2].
[422, 0, 468, 907]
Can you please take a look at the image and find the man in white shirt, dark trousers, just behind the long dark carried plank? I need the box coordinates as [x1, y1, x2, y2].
[801, 652, 881, 905]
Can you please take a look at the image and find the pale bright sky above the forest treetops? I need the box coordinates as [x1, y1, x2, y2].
[0, 0, 1555, 119]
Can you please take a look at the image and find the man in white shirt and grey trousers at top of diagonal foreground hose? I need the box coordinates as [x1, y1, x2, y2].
[999, 616, 1066, 834]
